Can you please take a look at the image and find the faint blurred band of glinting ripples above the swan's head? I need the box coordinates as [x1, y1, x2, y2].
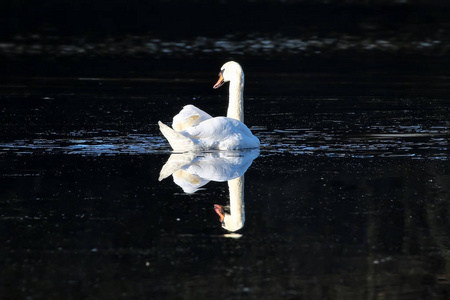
[0, 33, 450, 58]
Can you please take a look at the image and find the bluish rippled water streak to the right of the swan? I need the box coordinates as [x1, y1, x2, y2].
[257, 127, 450, 160]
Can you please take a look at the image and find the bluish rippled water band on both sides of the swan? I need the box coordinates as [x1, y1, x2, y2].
[0, 126, 450, 160]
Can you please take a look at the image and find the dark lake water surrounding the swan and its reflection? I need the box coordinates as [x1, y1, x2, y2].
[0, 73, 450, 299]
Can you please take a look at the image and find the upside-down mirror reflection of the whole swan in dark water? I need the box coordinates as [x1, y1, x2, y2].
[159, 149, 259, 232]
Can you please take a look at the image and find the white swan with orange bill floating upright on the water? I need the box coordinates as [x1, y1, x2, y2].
[158, 61, 259, 152]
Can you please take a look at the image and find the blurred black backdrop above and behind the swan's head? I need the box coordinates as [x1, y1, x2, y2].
[0, 0, 450, 77]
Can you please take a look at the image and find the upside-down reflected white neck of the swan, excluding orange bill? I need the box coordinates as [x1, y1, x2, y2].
[226, 176, 245, 231]
